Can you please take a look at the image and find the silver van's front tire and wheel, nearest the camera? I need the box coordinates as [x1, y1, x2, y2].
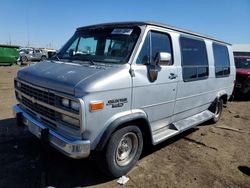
[99, 125, 143, 178]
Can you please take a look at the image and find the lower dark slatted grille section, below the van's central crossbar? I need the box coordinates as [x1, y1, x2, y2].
[21, 97, 56, 121]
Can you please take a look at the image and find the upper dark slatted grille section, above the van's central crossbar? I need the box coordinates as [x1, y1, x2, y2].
[20, 83, 55, 105]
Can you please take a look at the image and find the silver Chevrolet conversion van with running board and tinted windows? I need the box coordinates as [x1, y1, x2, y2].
[13, 22, 235, 177]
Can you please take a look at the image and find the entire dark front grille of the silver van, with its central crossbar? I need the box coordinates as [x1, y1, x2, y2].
[15, 80, 80, 128]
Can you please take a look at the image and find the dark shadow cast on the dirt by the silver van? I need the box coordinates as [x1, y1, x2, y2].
[0, 118, 198, 187]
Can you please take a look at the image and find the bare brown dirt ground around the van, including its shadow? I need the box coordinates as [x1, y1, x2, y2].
[0, 66, 250, 188]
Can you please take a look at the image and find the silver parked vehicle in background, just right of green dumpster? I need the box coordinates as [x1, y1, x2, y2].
[19, 48, 48, 64]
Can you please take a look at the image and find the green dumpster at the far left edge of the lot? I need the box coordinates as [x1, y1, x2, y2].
[0, 44, 19, 65]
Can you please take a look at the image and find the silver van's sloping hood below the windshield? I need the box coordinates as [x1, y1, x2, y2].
[17, 61, 106, 95]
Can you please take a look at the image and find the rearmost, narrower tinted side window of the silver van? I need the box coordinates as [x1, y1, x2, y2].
[213, 43, 230, 77]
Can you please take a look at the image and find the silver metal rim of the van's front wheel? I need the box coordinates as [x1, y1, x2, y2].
[116, 132, 138, 166]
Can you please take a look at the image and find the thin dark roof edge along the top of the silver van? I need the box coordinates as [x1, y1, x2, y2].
[77, 21, 231, 45]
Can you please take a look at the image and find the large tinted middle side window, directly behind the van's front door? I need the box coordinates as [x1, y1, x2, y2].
[180, 37, 208, 81]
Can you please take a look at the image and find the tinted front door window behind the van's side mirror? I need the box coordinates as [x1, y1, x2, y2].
[136, 31, 172, 65]
